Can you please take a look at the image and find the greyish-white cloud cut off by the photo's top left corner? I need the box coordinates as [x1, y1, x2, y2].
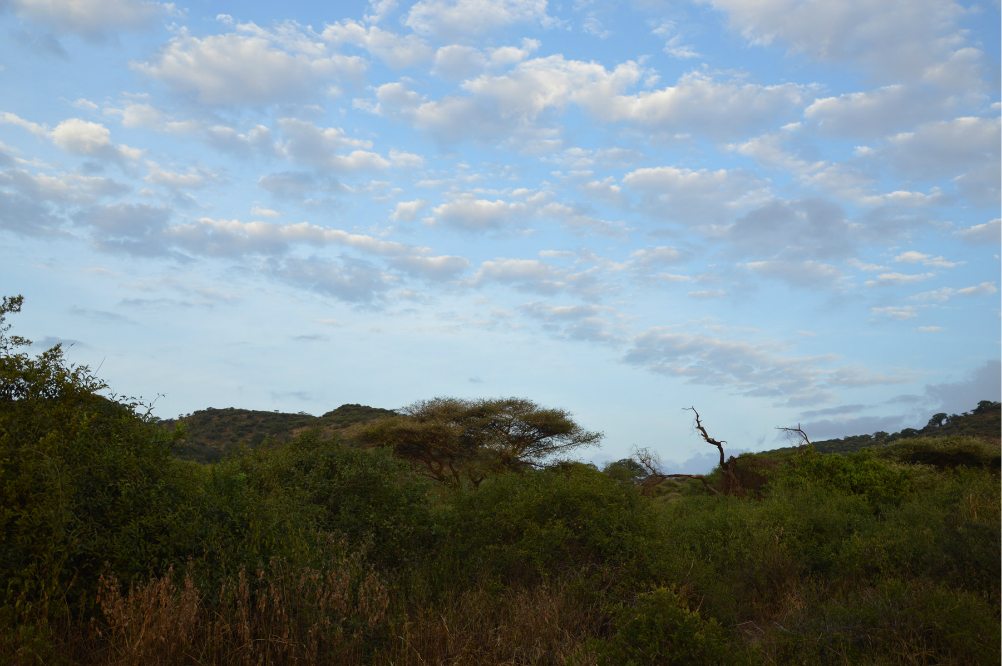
[0, 0, 177, 39]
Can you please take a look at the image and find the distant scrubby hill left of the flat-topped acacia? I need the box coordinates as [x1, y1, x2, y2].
[161, 405, 396, 463]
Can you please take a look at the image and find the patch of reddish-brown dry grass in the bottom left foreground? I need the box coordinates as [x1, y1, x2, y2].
[73, 556, 390, 666]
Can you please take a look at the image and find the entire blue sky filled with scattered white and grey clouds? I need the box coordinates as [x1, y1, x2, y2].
[0, 0, 1002, 469]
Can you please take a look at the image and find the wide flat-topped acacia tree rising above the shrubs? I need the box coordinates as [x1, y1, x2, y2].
[356, 398, 602, 487]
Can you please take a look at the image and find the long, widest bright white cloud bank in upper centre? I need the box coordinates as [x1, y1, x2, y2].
[372, 55, 804, 147]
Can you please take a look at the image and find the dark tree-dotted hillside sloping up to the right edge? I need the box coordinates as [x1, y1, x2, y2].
[808, 400, 1002, 454]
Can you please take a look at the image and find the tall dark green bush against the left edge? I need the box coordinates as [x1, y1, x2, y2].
[0, 347, 190, 606]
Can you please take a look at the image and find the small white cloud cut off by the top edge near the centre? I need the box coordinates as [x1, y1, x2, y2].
[405, 0, 553, 40]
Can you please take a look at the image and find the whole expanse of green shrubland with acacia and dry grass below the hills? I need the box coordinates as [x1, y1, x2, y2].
[0, 298, 1000, 666]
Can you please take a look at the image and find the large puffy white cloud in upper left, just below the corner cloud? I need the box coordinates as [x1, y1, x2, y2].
[132, 24, 367, 105]
